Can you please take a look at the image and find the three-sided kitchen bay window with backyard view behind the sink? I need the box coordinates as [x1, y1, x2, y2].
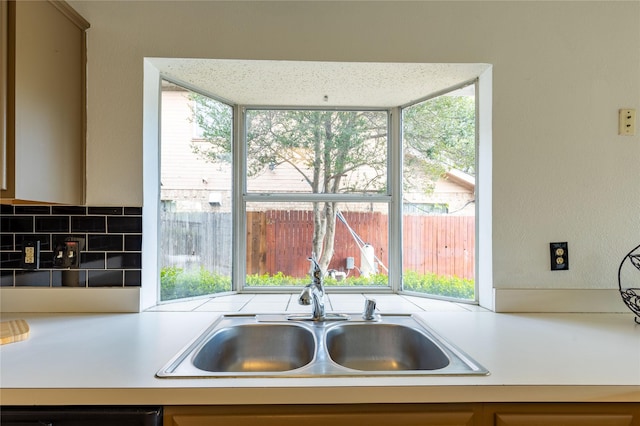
[148, 59, 490, 310]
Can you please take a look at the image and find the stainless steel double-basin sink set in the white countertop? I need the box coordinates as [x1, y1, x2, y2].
[156, 315, 488, 378]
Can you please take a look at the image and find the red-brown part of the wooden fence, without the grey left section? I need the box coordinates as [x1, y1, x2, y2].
[247, 210, 475, 279]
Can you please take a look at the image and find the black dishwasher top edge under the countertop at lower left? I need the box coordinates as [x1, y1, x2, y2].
[0, 406, 162, 426]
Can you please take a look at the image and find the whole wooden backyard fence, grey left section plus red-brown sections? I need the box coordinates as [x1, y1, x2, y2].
[160, 210, 475, 279]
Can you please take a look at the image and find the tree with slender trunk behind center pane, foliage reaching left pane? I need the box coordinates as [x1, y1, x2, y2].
[192, 95, 387, 270]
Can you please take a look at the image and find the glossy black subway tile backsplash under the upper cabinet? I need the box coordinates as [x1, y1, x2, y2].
[0, 205, 142, 287]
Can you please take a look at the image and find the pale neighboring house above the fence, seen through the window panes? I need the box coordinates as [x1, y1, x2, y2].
[160, 86, 475, 216]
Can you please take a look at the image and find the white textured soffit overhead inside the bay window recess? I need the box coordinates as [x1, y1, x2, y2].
[147, 58, 489, 107]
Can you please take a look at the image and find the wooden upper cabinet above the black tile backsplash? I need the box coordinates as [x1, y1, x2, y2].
[0, 0, 89, 205]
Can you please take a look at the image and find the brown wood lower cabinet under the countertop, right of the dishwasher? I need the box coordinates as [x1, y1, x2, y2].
[164, 403, 640, 426]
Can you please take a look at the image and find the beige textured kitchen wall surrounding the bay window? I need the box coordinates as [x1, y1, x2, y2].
[70, 1, 640, 289]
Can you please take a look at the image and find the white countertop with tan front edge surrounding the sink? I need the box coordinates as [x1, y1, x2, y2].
[0, 312, 640, 405]
